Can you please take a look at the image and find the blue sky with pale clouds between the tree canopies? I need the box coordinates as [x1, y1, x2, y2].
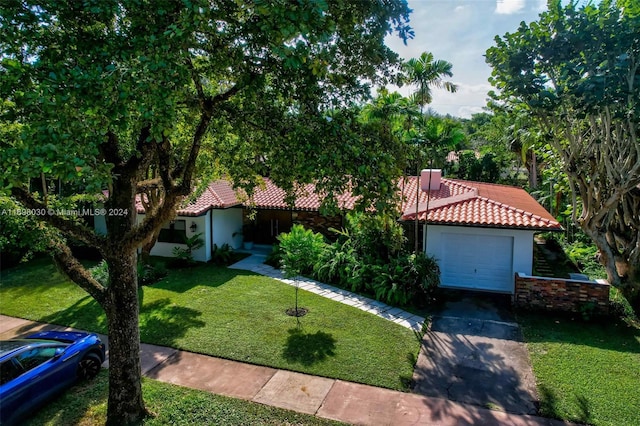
[387, 0, 547, 118]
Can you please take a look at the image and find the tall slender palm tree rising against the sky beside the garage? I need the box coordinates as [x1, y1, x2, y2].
[404, 52, 458, 253]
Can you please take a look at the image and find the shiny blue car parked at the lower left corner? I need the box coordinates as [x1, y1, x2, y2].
[0, 331, 106, 425]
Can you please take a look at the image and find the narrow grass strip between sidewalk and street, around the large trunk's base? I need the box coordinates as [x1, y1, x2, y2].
[25, 371, 342, 426]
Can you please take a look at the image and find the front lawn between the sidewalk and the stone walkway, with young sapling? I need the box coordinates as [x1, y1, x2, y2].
[0, 255, 420, 390]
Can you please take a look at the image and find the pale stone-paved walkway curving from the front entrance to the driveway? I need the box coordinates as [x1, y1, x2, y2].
[229, 251, 425, 331]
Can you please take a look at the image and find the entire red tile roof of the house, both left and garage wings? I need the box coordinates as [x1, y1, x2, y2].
[136, 176, 562, 230]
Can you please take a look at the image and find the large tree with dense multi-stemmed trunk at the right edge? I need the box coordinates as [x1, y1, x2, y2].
[486, 0, 640, 310]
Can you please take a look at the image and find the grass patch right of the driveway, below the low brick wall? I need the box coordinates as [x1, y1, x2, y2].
[518, 314, 640, 426]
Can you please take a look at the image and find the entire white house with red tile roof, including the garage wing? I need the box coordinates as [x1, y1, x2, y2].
[127, 170, 562, 294]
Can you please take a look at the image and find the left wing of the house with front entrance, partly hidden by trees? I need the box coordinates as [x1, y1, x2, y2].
[127, 178, 356, 262]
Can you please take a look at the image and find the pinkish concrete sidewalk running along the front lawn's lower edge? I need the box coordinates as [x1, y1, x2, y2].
[0, 315, 564, 426]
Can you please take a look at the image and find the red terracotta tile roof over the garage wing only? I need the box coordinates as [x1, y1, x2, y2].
[402, 176, 562, 230]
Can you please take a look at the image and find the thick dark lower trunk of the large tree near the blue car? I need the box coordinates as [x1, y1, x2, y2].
[104, 250, 147, 426]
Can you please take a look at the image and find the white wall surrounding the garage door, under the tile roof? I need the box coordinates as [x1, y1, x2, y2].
[425, 225, 534, 275]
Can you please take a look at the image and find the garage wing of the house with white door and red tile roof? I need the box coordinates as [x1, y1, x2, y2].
[401, 170, 562, 294]
